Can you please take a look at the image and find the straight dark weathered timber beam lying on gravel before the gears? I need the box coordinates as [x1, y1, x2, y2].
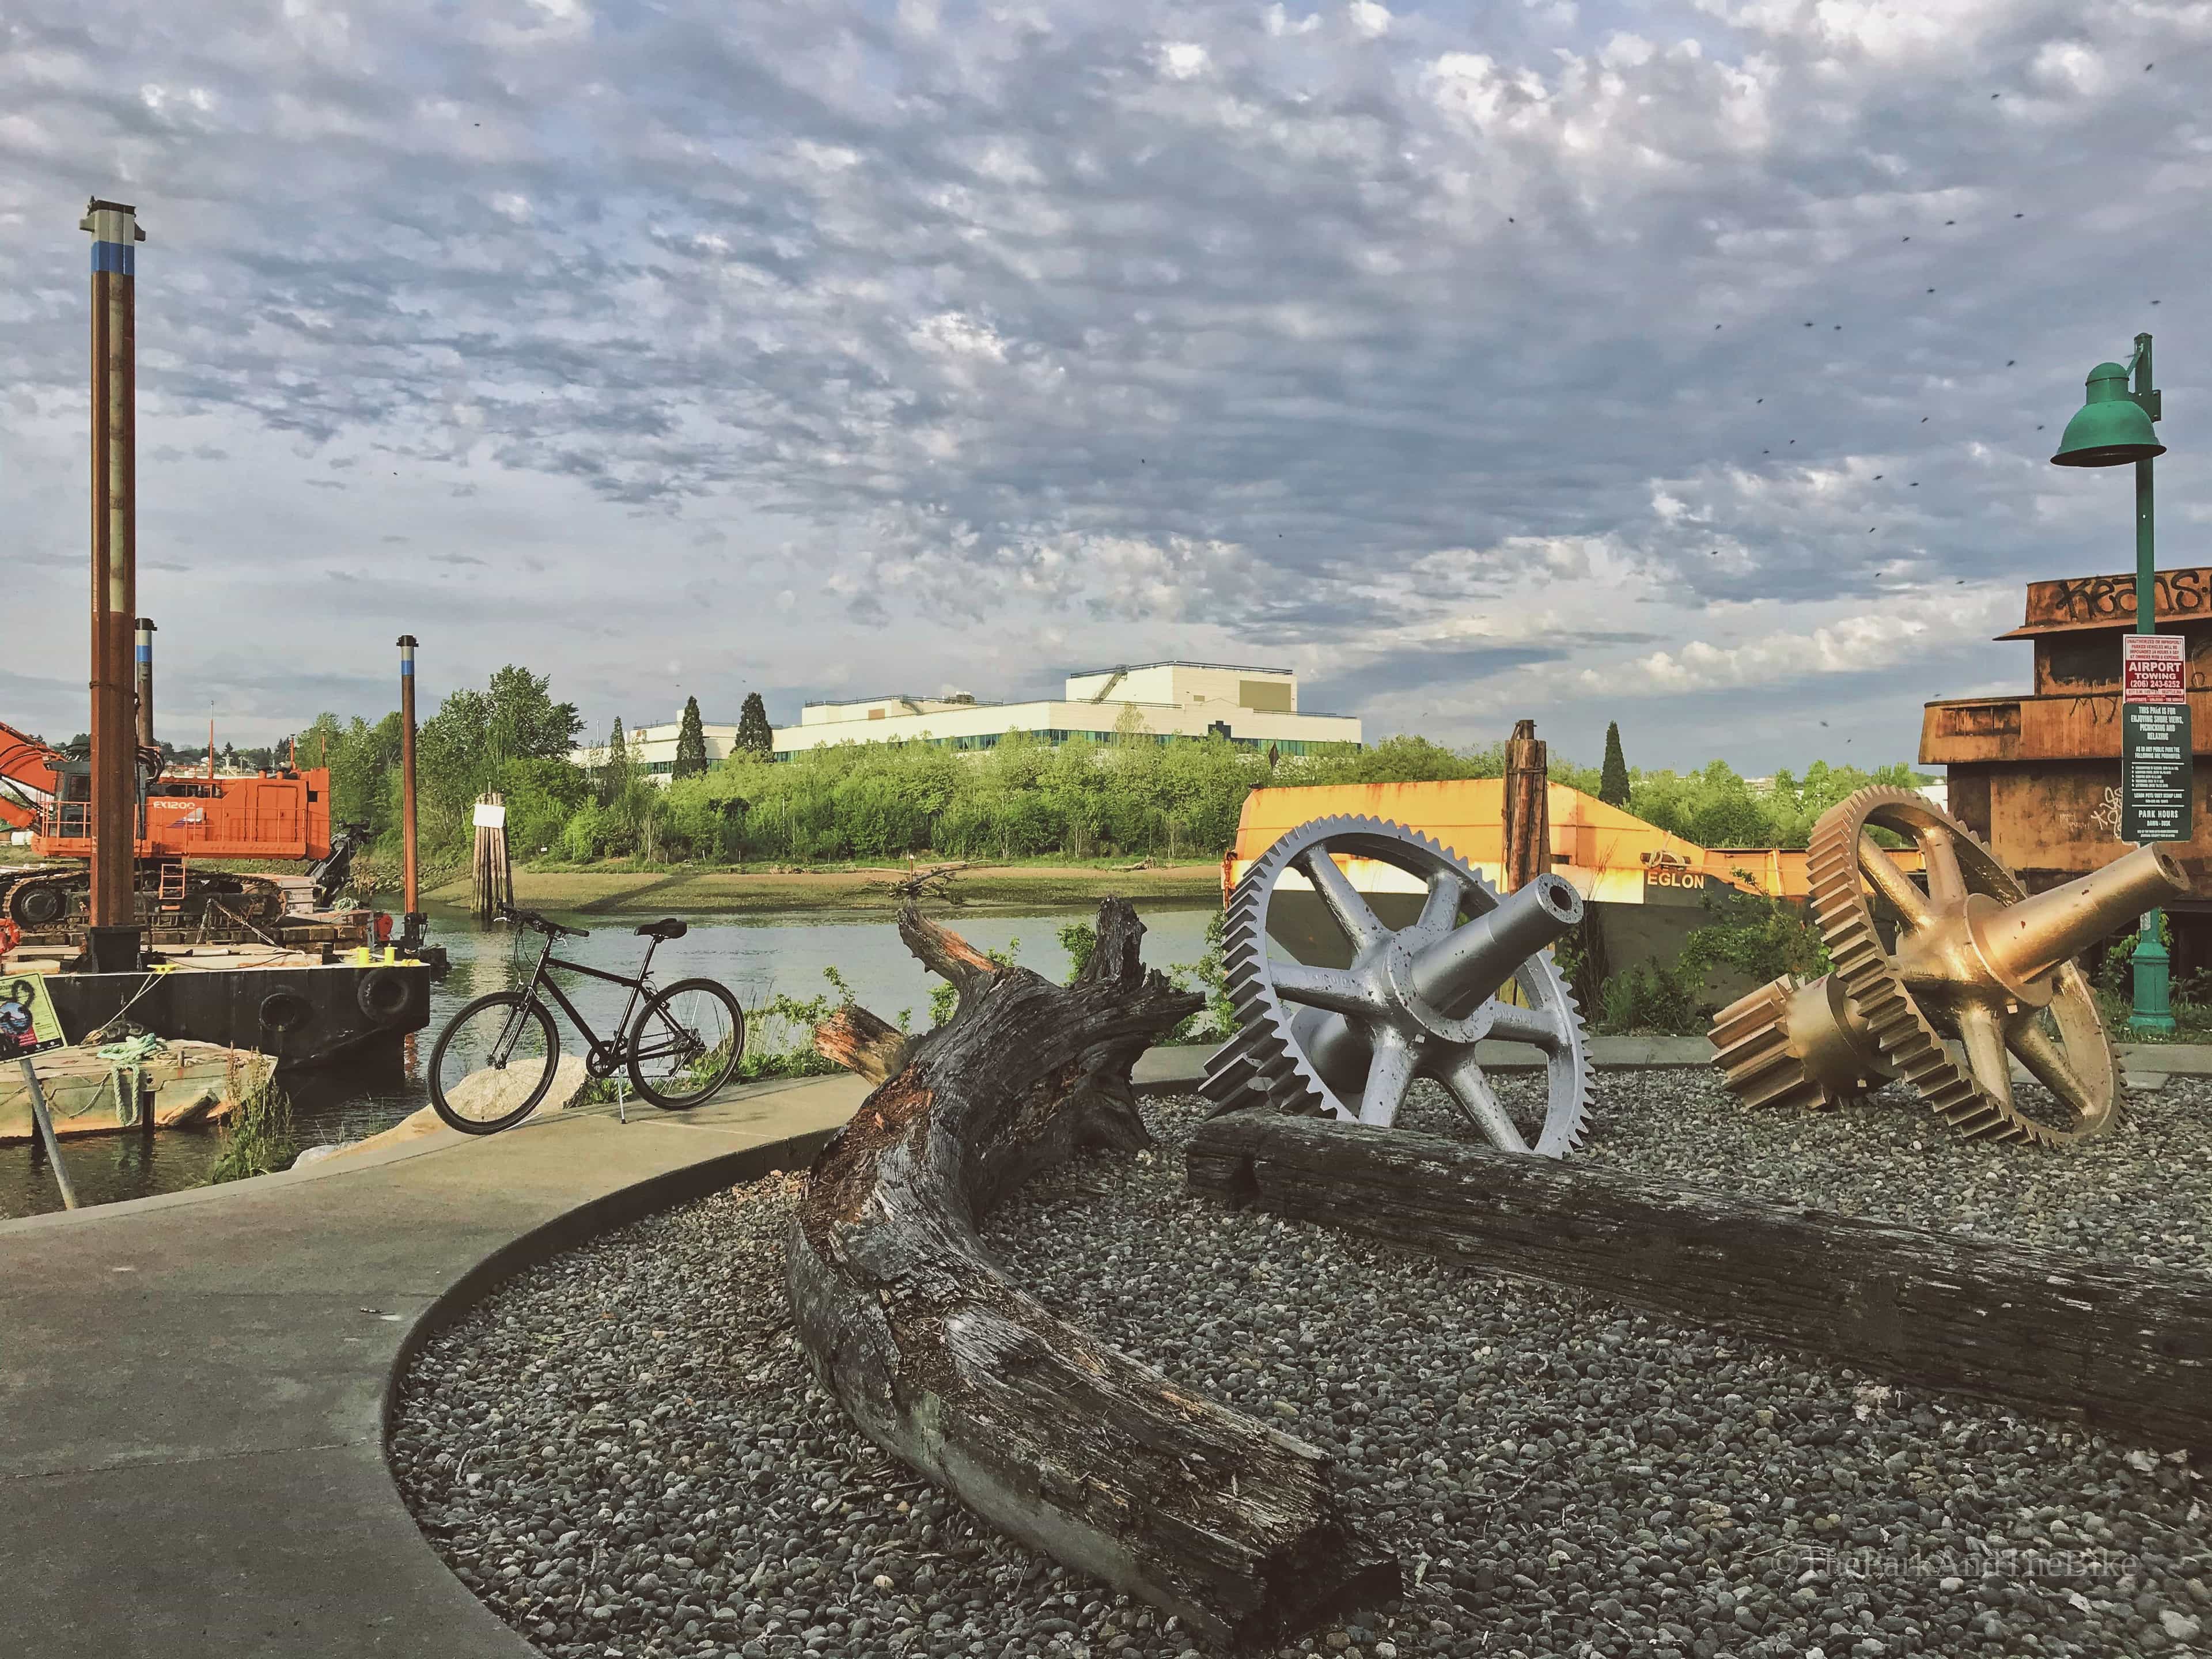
[1183, 1113, 2212, 1451]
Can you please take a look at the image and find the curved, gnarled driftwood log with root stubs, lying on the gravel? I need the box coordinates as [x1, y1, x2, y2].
[790, 898, 1398, 1646]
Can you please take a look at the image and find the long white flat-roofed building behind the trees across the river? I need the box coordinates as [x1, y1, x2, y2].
[760, 661, 1361, 761]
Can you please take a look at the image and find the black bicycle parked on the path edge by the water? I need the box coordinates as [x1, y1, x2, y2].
[429, 905, 745, 1135]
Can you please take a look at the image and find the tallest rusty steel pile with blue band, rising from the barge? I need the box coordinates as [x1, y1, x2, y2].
[77, 197, 146, 974]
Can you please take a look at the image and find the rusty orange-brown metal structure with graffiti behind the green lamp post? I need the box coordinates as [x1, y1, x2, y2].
[1920, 566, 2212, 902]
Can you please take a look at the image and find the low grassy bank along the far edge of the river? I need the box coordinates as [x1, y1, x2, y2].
[407, 863, 1221, 916]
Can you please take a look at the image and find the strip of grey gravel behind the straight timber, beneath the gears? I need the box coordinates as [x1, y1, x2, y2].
[1398, 1069, 2212, 1272]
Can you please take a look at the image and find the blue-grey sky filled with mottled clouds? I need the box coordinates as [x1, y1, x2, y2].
[0, 0, 2212, 770]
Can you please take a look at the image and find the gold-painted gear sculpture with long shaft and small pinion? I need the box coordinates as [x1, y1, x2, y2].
[1712, 787, 2188, 1146]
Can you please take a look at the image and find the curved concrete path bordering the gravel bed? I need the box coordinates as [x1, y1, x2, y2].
[0, 1077, 867, 1659]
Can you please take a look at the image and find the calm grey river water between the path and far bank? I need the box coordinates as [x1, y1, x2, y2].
[0, 903, 1212, 1219]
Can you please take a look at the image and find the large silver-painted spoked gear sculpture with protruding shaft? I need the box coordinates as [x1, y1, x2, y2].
[1201, 819, 1590, 1157]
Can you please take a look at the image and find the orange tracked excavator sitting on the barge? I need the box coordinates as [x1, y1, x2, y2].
[0, 721, 363, 940]
